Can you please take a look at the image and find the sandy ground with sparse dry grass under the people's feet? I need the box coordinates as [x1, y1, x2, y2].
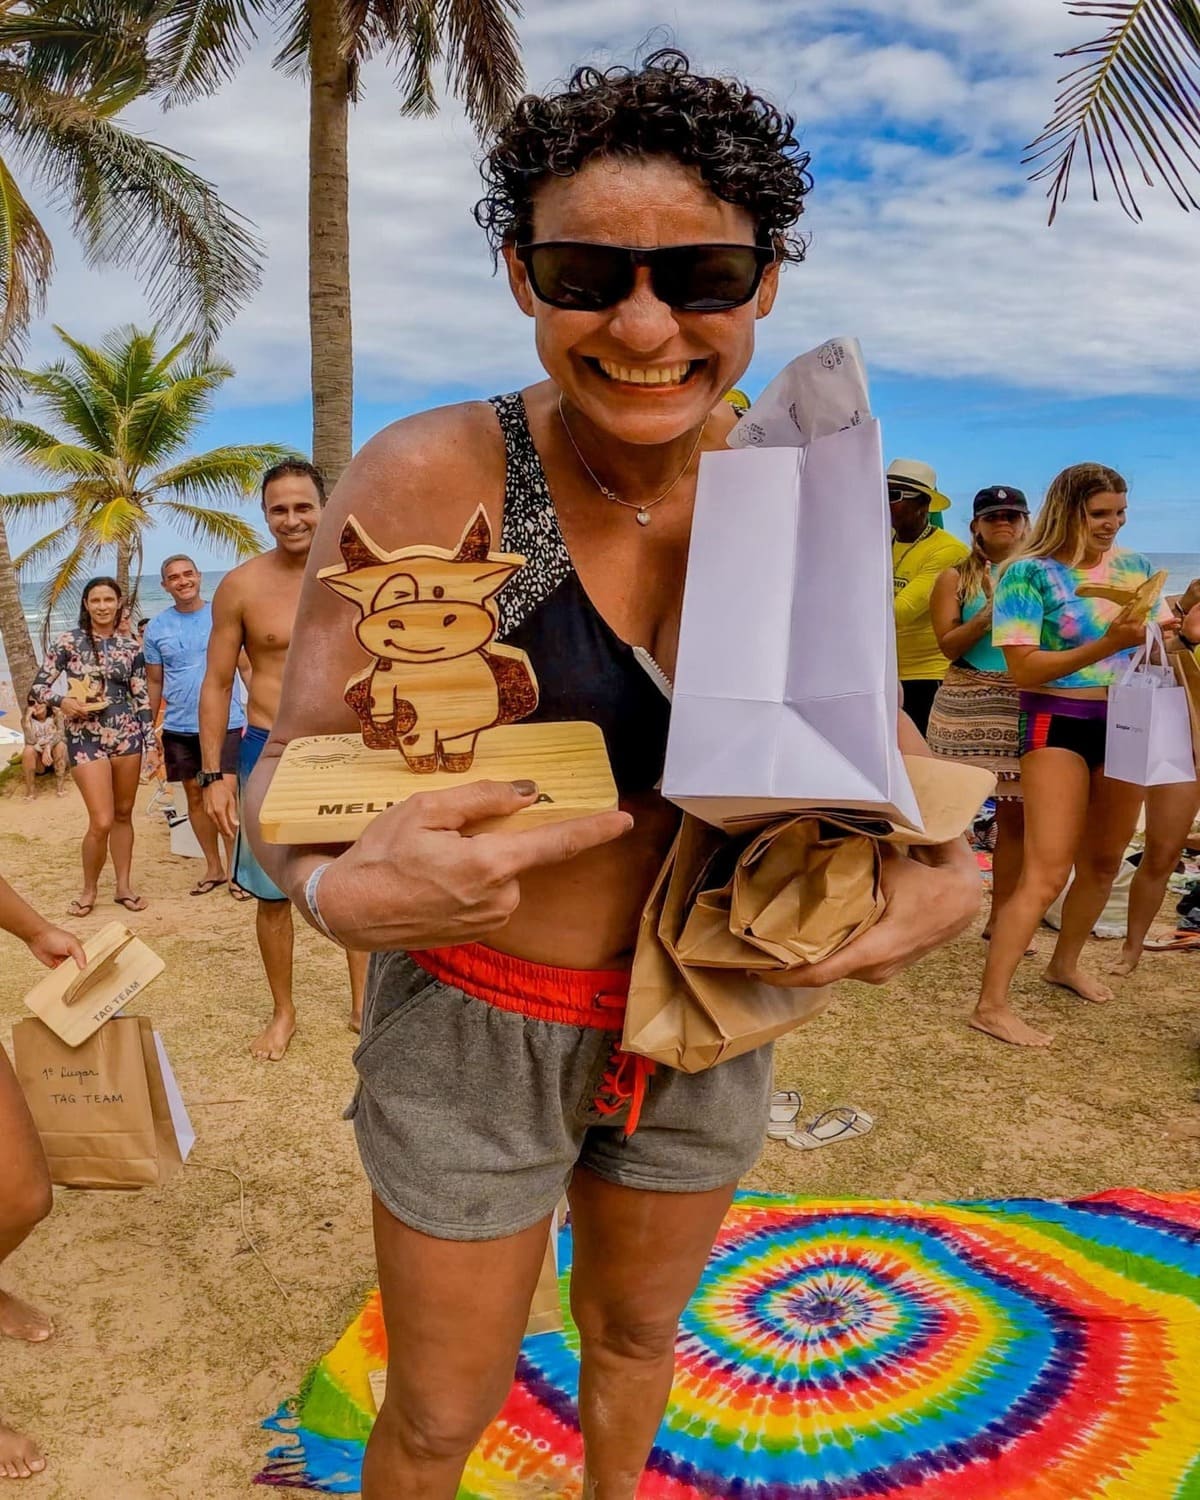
[0, 785, 1200, 1500]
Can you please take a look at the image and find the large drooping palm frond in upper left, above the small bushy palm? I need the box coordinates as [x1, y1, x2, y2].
[6, 92, 263, 348]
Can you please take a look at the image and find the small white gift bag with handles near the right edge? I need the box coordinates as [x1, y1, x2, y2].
[1104, 624, 1196, 786]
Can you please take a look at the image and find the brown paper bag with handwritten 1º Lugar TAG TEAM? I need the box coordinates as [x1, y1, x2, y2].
[12, 1016, 182, 1188]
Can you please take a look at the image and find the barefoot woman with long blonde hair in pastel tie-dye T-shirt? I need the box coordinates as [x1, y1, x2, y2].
[971, 464, 1170, 1047]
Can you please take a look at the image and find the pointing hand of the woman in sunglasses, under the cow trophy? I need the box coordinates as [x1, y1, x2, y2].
[309, 782, 633, 951]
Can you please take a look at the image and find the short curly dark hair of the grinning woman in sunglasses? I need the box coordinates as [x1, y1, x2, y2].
[476, 48, 813, 261]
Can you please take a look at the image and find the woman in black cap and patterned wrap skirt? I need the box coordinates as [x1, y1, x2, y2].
[926, 485, 1029, 938]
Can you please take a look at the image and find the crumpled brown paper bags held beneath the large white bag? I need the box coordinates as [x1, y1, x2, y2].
[621, 756, 996, 1073]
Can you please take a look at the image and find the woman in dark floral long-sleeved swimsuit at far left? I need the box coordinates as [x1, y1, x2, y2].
[30, 578, 152, 917]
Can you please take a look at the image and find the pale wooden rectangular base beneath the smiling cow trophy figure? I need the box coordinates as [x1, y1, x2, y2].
[258, 723, 617, 845]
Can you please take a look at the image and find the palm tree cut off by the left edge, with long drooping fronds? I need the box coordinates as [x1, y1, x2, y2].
[0, 0, 261, 701]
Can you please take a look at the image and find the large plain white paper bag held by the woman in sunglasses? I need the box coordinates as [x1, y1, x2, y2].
[663, 419, 921, 830]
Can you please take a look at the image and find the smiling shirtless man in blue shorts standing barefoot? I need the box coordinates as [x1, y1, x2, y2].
[197, 459, 368, 1062]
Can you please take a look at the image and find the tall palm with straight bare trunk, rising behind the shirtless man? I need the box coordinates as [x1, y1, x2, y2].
[143, 0, 524, 483]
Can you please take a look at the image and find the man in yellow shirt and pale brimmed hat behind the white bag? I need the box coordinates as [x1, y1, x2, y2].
[888, 459, 971, 734]
